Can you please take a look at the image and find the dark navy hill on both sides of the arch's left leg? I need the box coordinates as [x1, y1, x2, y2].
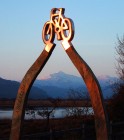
[0, 78, 48, 99]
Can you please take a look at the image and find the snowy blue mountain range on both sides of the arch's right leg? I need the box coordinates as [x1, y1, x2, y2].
[34, 71, 117, 98]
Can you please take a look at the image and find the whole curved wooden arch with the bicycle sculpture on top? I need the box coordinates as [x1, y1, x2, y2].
[10, 8, 109, 140]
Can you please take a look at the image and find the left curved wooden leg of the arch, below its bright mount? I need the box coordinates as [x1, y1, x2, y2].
[10, 45, 55, 140]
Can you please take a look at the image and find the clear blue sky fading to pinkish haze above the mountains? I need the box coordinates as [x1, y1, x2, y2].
[0, 0, 124, 80]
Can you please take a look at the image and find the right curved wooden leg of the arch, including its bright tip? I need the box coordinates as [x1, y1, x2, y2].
[62, 41, 109, 140]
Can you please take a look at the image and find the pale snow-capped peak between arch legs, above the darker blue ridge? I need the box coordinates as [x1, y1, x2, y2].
[34, 71, 85, 89]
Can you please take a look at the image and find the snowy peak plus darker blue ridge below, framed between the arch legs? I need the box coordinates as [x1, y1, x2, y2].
[34, 71, 86, 99]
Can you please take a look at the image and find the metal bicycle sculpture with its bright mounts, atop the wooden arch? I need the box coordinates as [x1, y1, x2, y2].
[42, 8, 74, 52]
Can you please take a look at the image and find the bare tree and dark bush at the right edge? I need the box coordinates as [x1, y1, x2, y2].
[109, 36, 124, 121]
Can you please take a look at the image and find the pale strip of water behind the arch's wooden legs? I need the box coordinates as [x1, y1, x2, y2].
[0, 107, 93, 119]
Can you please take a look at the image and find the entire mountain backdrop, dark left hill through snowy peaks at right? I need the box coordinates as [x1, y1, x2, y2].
[0, 71, 117, 99]
